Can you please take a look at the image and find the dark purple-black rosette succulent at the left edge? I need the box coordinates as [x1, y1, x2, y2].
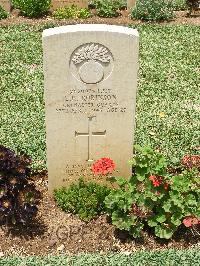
[0, 145, 38, 224]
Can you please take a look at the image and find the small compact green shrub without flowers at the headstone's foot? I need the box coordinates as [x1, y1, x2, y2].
[54, 179, 110, 222]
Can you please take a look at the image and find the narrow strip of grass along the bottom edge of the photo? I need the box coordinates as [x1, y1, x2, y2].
[0, 249, 200, 266]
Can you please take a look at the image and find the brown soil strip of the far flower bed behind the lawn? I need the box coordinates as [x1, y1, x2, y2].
[0, 10, 200, 26]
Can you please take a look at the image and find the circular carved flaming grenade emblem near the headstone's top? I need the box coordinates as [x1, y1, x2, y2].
[70, 43, 113, 84]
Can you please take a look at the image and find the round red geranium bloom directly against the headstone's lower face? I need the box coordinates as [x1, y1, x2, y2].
[92, 158, 115, 175]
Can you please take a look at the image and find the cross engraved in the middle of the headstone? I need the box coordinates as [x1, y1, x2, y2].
[75, 116, 106, 162]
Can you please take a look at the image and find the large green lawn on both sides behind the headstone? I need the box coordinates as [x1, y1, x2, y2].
[0, 25, 200, 169]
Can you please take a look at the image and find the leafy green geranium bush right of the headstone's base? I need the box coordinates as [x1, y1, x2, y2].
[105, 146, 200, 239]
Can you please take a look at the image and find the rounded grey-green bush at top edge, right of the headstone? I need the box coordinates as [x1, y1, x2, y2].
[131, 0, 174, 21]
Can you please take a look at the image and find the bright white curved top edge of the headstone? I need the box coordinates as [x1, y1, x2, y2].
[42, 24, 139, 38]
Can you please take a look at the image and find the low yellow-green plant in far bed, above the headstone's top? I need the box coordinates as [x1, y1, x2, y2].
[53, 5, 92, 19]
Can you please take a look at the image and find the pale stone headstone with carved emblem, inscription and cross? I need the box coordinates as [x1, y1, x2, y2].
[43, 24, 139, 193]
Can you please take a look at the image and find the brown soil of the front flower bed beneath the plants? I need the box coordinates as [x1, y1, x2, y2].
[0, 173, 200, 256]
